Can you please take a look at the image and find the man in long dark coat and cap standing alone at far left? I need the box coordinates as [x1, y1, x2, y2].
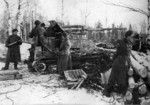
[2, 29, 22, 70]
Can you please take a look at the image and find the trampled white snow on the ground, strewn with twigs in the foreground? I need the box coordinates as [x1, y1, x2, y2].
[0, 43, 150, 105]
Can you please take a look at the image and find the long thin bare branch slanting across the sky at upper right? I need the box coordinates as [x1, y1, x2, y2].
[103, 2, 149, 16]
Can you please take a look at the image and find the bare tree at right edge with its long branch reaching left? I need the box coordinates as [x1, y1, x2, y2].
[103, 0, 150, 35]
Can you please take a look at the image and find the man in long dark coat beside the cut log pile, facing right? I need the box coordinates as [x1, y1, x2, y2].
[104, 31, 134, 97]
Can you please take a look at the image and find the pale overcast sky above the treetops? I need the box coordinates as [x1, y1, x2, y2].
[0, 0, 147, 28]
